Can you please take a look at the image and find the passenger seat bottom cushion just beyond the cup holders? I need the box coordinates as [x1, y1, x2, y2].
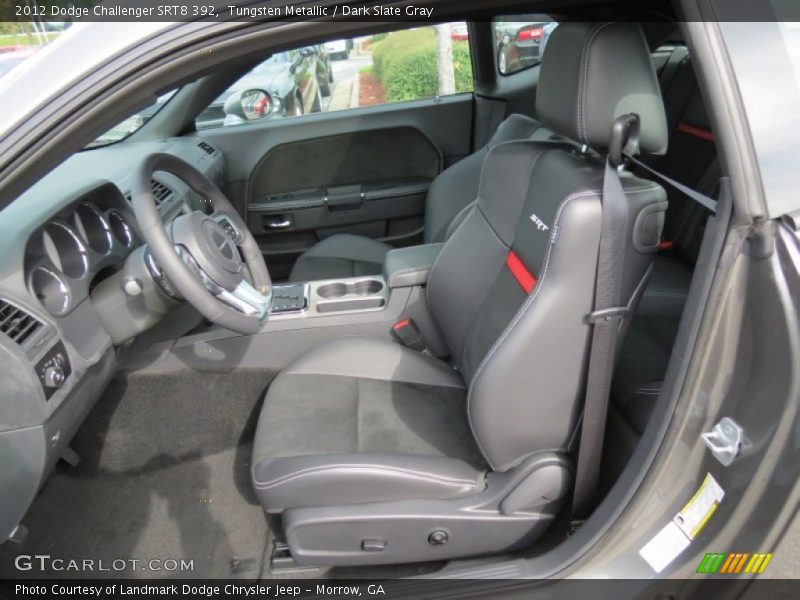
[289, 234, 392, 282]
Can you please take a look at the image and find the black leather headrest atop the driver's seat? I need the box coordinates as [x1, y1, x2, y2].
[536, 22, 668, 154]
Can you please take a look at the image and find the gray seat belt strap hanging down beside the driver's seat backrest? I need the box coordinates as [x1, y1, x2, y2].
[572, 115, 639, 519]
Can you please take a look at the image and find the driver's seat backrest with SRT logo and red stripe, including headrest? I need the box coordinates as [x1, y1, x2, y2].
[428, 23, 667, 471]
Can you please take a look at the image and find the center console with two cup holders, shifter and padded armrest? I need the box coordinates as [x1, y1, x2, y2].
[126, 244, 447, 372]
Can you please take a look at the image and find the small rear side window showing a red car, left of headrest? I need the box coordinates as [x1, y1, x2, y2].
[494, 15, 558, 75]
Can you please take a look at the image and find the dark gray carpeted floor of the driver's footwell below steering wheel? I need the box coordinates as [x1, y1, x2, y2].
[0, 370, 269, 578]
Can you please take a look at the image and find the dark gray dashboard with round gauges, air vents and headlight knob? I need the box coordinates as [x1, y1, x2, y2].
[0, 136, 225, 539]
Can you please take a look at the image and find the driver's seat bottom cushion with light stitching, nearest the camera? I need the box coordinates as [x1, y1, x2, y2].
[252, 338, 485, 512]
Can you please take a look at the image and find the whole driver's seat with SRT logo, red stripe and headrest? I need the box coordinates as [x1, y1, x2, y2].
[252, 23, 667, 565]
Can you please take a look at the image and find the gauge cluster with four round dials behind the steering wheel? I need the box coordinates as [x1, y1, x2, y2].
[25, 183, 139, 317]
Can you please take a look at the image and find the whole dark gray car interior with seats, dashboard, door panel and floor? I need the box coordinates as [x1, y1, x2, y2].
[0, 12, 723, 578]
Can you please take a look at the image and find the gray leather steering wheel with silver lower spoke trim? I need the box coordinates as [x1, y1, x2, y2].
[131, 153, 272, 335]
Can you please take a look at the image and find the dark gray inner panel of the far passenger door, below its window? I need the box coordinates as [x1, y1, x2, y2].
[198, 94, 472, 279]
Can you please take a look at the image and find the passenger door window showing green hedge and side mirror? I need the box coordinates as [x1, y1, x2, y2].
[195, 22, 473, 129]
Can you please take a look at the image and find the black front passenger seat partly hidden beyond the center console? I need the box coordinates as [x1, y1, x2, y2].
[289, 119, 551, 282]
